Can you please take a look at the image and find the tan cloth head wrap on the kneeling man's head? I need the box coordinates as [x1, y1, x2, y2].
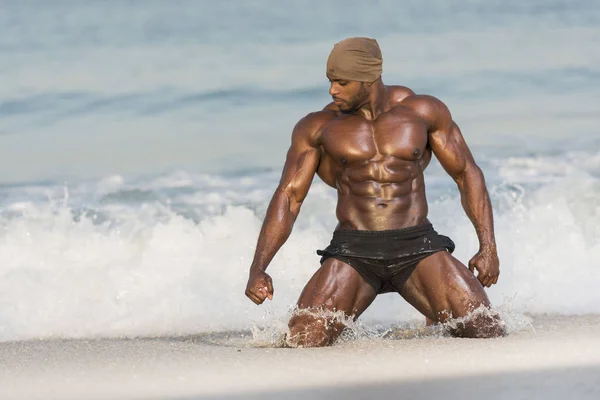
[327, 37, 383, 82]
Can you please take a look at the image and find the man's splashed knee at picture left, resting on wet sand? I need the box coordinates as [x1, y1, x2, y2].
[286, 315, 340, 347]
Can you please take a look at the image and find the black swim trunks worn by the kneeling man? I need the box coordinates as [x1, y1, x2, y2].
[317, 223, 455, 293]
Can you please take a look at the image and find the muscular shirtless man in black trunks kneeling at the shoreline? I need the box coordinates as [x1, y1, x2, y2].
[246, 38, 504, 347]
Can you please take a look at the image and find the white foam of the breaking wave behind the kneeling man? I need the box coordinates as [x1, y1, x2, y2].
[0, 166, 600, 340]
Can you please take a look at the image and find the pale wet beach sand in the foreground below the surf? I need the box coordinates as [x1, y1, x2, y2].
[0, 315, 600, 400]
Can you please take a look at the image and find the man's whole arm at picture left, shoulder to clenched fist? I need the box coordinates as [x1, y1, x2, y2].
[246, 113, 325, 304]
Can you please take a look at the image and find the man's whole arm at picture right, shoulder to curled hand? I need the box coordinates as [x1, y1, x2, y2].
[405, 95, 500, 287]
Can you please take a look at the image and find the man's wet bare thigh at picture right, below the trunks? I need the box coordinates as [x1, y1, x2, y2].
[400, 251, 490, 322]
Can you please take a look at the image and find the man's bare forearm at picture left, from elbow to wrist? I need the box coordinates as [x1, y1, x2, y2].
[250, 189, 298, 273]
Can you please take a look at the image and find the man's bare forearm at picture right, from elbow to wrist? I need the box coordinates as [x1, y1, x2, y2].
[457, 164, 496, 249]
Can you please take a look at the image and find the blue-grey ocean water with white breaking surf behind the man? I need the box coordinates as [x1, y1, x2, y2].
[0, 0, 600, 341]
